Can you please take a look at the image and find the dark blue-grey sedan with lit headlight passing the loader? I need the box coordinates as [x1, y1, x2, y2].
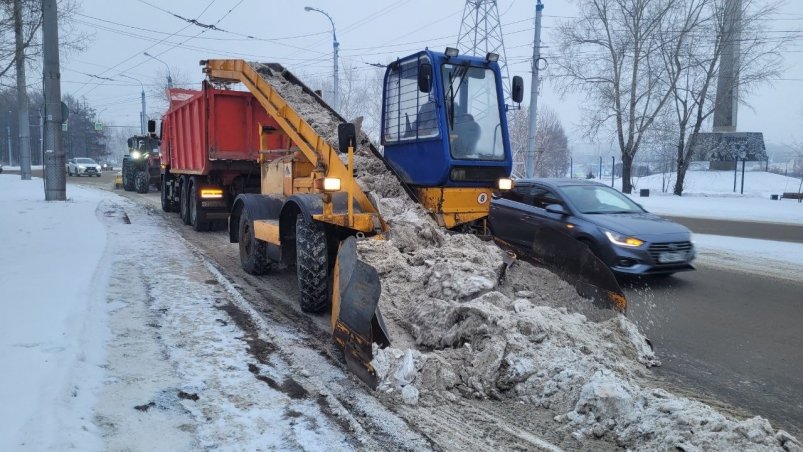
[489, 179, 695, 275]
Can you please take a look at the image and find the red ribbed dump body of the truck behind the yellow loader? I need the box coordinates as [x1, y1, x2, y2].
[161, 84, 289, 176]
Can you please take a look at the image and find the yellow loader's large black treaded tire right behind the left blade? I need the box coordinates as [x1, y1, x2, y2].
[296, 215, 329, 312]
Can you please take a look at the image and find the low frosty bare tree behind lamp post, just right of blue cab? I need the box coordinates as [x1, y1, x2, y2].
[508, 106, 571, 177]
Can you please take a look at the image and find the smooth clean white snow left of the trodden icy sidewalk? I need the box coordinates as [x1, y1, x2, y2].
[0, 174, 109, 450]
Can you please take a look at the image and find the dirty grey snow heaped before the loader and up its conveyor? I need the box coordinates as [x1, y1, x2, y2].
[248, 65, 798, 450]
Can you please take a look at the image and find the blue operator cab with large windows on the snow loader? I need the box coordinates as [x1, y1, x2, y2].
[382, 48, 522, 188]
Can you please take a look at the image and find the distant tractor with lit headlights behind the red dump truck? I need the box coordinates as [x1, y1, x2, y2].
[123, 121, 161, 193]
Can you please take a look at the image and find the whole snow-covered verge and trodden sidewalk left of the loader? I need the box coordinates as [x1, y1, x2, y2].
[0, 175, 359, 451]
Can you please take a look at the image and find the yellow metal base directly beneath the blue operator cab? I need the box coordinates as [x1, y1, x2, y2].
[416, 187, 491, 229]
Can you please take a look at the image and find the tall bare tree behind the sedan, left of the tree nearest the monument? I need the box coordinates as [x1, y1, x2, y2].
[557, 0, 693, 193]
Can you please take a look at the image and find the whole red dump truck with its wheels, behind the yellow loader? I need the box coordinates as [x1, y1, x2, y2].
[160, 86, 292, 231]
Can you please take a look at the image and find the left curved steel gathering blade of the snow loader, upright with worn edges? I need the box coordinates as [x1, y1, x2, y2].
[332, 237, 390, 389]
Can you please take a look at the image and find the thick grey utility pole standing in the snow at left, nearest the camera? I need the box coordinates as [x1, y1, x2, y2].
[42, 0, 67, 201]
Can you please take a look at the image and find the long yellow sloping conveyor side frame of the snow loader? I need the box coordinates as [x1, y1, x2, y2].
[204, 60, 388, 232]
